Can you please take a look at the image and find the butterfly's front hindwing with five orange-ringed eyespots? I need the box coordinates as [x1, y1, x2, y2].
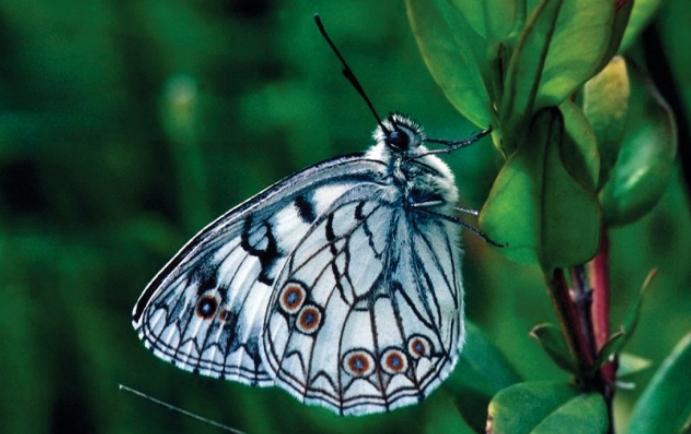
[262, 186, 464, 414]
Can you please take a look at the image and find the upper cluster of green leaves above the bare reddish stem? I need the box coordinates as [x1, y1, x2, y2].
[407, 0, 676, 269]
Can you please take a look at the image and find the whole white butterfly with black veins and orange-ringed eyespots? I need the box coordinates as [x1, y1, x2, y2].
[132, 13, 488, 415]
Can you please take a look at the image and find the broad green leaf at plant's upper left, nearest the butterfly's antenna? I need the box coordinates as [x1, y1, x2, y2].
[405, 0, 492, 128]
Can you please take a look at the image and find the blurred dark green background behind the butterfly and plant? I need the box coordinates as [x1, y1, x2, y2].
[0, 0, 691, 433]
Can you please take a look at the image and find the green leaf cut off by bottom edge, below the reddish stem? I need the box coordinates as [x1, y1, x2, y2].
[487, 382, 608, 434]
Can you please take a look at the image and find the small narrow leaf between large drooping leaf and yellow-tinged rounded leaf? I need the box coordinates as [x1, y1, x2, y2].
[559, 99, 600, 192]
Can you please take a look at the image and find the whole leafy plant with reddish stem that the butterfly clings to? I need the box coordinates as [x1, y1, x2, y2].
[407, 0, 688, 432]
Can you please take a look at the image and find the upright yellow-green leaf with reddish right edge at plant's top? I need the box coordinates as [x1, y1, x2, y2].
[537, 0, 615, 108]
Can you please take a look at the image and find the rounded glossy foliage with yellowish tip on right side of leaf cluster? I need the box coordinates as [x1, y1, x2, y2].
[583, 57, 677, 225]
